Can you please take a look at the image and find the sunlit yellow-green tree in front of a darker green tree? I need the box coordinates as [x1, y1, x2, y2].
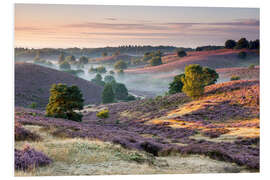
[181, 64, 205, 99]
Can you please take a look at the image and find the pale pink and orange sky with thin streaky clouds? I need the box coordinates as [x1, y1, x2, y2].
[14, 4, 260, 48]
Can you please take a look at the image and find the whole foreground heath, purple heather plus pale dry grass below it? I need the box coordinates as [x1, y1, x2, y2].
[15, 80, 260, 176]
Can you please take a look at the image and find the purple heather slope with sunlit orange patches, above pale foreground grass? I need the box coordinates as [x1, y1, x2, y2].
[15, 80, 260, 172]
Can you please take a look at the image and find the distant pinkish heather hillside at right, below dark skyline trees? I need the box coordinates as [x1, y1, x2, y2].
[125, 49, 259, 73]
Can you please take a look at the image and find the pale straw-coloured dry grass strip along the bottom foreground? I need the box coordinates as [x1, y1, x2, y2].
[15, 125, 249, 176]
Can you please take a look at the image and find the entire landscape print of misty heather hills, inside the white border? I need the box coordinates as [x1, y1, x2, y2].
[13, 4, 260, 176]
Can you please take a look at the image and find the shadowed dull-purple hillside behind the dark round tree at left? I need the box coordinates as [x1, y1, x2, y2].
[15, 63, 102, 109]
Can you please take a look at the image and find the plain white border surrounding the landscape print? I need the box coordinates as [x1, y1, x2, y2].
[0, 0, 270, 180]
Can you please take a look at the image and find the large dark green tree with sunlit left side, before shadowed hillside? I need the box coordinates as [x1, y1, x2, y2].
[46, 83, 84, 121]
